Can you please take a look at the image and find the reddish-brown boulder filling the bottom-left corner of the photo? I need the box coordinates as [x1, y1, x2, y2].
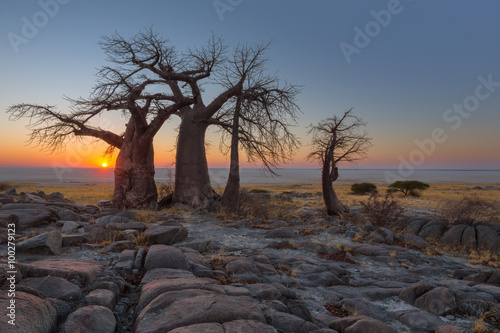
[0, 290, 57, 333]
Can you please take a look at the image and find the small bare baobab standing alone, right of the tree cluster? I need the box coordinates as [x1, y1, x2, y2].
[307, 108, 372, 217]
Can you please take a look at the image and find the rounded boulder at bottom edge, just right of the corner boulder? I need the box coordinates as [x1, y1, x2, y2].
[61, 305, 116, 333]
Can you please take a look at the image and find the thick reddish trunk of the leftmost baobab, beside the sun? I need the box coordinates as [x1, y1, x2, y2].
[113, 122, 158, 209]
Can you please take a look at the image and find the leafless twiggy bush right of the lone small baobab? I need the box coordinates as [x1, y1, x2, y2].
[361, 194, 403, 227]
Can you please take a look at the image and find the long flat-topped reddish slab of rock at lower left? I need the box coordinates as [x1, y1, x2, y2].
[24, 259, 101, 284]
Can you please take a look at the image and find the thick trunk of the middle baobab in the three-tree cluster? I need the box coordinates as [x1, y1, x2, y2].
[172, 110, 217, 208]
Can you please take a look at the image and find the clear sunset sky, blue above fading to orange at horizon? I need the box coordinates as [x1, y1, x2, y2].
[0, 0, 500, 169]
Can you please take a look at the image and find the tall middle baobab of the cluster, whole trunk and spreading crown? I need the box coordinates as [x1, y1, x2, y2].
[93, 31, 294, 207]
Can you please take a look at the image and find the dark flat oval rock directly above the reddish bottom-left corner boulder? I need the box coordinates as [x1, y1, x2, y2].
[21, 276, 82, 301]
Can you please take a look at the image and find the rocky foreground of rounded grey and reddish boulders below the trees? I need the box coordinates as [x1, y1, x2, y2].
[0, 190, 500, 333]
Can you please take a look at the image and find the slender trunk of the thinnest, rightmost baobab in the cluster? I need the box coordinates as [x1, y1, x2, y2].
[222, 98, 241, 211]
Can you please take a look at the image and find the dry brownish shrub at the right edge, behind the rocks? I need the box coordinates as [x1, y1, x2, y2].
[439, 196, 500, 224]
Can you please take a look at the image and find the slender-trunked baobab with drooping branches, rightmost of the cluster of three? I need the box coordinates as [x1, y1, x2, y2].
[213, 44, 300, 211]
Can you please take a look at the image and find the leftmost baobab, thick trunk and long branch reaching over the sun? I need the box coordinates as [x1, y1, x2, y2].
[7, 74, 192, 208]
